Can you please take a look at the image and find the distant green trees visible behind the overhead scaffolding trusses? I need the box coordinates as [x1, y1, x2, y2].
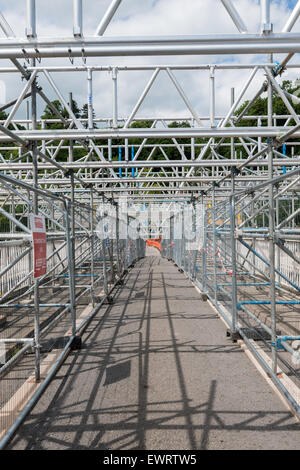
[0, 80, 300, 231]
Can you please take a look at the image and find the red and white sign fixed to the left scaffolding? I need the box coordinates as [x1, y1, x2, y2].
[31, 214, 47, 278]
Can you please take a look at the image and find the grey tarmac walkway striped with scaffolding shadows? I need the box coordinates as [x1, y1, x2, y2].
[8, 252, 300, 450]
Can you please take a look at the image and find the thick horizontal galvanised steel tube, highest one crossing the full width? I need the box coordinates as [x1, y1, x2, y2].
[0, 33, 300, 60]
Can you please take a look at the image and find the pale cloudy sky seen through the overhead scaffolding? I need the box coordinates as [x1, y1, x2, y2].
[0, 0, 300, 123]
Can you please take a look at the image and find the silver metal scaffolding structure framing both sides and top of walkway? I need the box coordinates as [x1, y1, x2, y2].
[0, 0, 300, 446]
